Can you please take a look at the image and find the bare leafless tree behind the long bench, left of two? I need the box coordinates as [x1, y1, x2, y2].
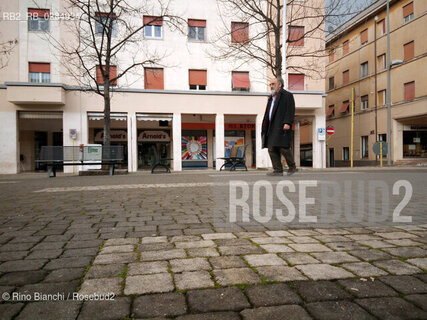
[45, 0, 180, 146]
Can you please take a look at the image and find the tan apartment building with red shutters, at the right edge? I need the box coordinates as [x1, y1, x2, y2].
[325, 0, 427, 166]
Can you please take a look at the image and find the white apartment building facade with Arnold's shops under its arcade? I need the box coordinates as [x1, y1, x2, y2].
[0, 0, 325, 173]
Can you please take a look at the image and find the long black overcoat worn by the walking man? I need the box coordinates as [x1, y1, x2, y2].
[261, 89, 295, 148]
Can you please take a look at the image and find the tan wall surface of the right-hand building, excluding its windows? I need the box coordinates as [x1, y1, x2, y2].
[325, 0, 427, 165]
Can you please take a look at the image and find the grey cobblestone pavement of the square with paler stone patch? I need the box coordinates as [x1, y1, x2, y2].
[0, 169, 427, 320]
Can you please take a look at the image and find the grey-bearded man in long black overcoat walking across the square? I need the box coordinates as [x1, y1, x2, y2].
[261, 77, 296, 176]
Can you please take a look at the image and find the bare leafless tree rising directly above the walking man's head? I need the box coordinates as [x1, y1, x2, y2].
[211, 0, 370, 78]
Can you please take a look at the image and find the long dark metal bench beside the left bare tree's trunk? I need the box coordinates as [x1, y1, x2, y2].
[36, 146, 124, 177]
